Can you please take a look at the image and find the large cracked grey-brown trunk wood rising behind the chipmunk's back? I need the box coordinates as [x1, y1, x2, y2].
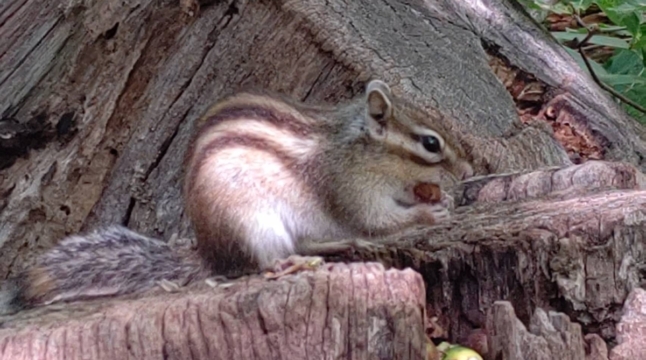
[0, 0, 584, 274]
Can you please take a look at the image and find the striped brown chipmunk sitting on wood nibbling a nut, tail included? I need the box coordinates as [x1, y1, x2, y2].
[0, 80, 473, 313]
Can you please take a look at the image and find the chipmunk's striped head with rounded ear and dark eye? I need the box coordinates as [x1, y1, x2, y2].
[365, 80, 473, 180]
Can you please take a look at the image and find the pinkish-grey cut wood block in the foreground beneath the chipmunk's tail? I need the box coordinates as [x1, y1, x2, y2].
[0, 264, 426, 360]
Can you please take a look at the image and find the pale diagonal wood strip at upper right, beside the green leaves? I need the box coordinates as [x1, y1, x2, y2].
[456, 0, 646, 166]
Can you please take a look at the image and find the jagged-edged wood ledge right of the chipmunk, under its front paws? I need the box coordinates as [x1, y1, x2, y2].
[334, 163, 646, 339]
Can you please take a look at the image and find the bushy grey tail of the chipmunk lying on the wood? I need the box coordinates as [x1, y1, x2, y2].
[0, 226, 208, 314]
